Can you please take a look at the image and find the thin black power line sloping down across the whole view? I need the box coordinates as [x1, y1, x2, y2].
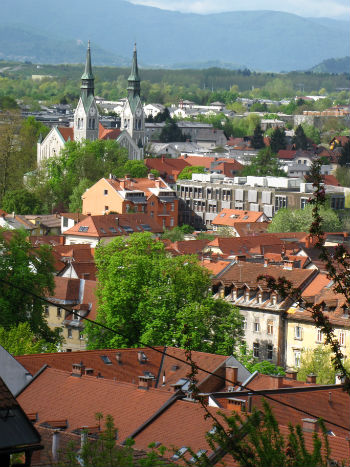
[0, 278, 350, 431]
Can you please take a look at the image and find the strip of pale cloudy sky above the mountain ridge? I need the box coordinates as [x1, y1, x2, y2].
[128, 0, 350, 20]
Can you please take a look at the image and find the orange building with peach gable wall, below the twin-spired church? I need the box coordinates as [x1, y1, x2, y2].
[82, 174, 179, 229]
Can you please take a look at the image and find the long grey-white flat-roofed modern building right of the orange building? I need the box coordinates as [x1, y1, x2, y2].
[176, 174, 345, 228]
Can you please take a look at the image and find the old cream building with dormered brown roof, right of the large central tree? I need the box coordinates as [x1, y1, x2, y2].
[213, 261, 318, 366]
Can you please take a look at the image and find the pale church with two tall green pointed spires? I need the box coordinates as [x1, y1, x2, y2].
[37, 41, 145, 167]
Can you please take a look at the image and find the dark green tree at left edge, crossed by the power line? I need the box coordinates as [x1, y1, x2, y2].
[0, 229, 58, 342]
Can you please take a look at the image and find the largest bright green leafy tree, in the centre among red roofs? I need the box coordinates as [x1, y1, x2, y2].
[86, 233, 242, 355]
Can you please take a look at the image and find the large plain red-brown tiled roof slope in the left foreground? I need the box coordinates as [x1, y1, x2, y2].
[17, 368, 169, 441]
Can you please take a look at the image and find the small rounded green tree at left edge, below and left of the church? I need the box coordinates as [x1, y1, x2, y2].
[1, 188, 42, 214]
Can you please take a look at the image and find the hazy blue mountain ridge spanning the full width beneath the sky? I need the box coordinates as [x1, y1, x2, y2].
[0, 0, 349, 71]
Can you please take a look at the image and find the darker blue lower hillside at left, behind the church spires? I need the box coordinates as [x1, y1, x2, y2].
[0, 24, 129, 66]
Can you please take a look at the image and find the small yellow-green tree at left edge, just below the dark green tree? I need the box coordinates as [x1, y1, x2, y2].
[0, 323, 57, 355]
